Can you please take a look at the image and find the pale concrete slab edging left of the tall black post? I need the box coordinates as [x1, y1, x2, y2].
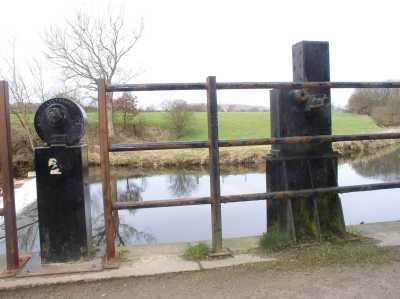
[0, 237, 275, 290]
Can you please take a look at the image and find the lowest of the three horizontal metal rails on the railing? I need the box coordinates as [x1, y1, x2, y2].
[113, 181, 400, 210]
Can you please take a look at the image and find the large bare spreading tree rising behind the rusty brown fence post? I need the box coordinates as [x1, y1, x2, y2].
[45, 12, 143, 135]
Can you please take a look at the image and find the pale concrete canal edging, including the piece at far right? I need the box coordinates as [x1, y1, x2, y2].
[0, 222, 400, 290]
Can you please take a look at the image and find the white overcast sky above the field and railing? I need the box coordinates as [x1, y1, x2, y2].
[0, 0, 400, 106]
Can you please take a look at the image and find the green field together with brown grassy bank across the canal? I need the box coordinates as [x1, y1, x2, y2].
[7, 112, 393, 175]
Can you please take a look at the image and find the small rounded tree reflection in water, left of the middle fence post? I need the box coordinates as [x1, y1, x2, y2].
[168, 170, 199, 197]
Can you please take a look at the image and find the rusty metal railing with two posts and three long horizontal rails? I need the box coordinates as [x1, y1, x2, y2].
[97, 76, 400, 261]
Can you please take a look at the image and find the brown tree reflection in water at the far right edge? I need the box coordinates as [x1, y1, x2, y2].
[351, 150, 400, 181]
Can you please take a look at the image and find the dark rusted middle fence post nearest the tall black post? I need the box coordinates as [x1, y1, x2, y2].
[206, 76, 222, 254]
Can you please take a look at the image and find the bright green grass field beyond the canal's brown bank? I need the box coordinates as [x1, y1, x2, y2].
[88, 112, 379, 140]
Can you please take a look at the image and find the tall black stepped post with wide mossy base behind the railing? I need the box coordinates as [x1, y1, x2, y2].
[267, 41, 345, 240]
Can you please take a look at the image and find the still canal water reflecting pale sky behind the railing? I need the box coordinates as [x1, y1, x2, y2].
[0, 149, 400, 252]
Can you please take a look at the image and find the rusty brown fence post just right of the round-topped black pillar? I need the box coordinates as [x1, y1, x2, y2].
[97, 80, 116, 263]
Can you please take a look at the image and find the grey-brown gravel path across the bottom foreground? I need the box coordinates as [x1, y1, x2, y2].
[0, 261, 400, 299]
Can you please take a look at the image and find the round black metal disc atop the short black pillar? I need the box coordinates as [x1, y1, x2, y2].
[34, 98, 86, 145]
